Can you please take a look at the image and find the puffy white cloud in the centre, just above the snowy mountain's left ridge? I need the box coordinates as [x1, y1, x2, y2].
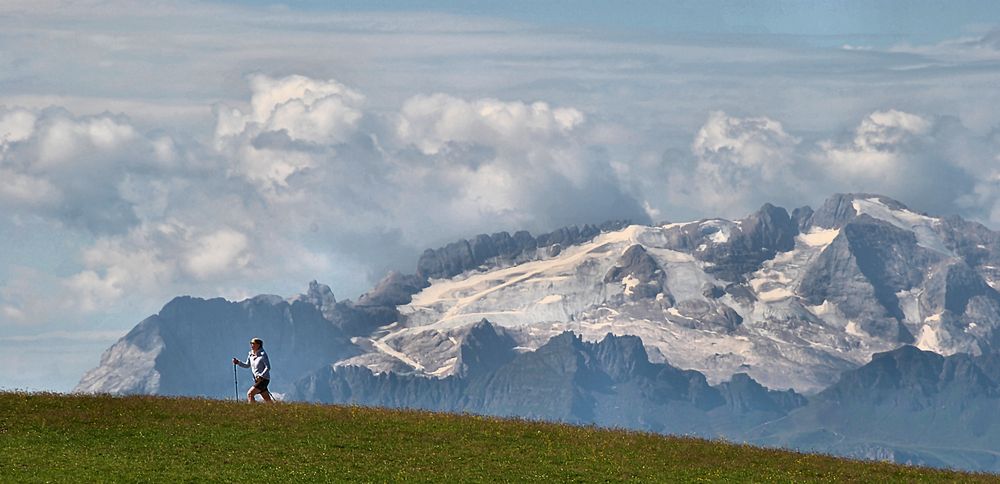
[386, 93, 647, 239]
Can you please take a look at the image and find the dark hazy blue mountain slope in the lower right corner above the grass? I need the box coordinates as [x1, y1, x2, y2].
[745, 346, 1000, 472]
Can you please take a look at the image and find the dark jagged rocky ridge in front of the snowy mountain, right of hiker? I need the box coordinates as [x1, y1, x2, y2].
[290, 320, 805, 435]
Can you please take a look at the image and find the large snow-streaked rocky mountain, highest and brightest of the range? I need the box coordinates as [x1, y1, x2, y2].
[338, 195, 1000, 392]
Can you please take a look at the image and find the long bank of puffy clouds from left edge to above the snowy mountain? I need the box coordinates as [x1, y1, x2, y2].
[0, 75, 648, 326]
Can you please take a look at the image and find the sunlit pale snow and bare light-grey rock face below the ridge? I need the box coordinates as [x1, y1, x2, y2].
[341, 220, 912, 392]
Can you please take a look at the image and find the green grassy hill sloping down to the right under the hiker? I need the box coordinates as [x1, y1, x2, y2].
[0, 393, 998, 482]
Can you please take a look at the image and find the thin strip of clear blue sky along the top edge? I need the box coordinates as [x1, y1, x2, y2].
[221, 0, 1000, 46]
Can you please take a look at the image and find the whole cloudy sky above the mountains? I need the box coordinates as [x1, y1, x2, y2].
[0, 0, 1000, 391]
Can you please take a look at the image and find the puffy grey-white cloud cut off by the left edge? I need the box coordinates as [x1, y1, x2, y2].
[0, 108, 175, 234]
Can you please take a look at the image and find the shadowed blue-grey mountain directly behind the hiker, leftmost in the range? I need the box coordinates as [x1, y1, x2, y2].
[75, 286, 359, 398]
